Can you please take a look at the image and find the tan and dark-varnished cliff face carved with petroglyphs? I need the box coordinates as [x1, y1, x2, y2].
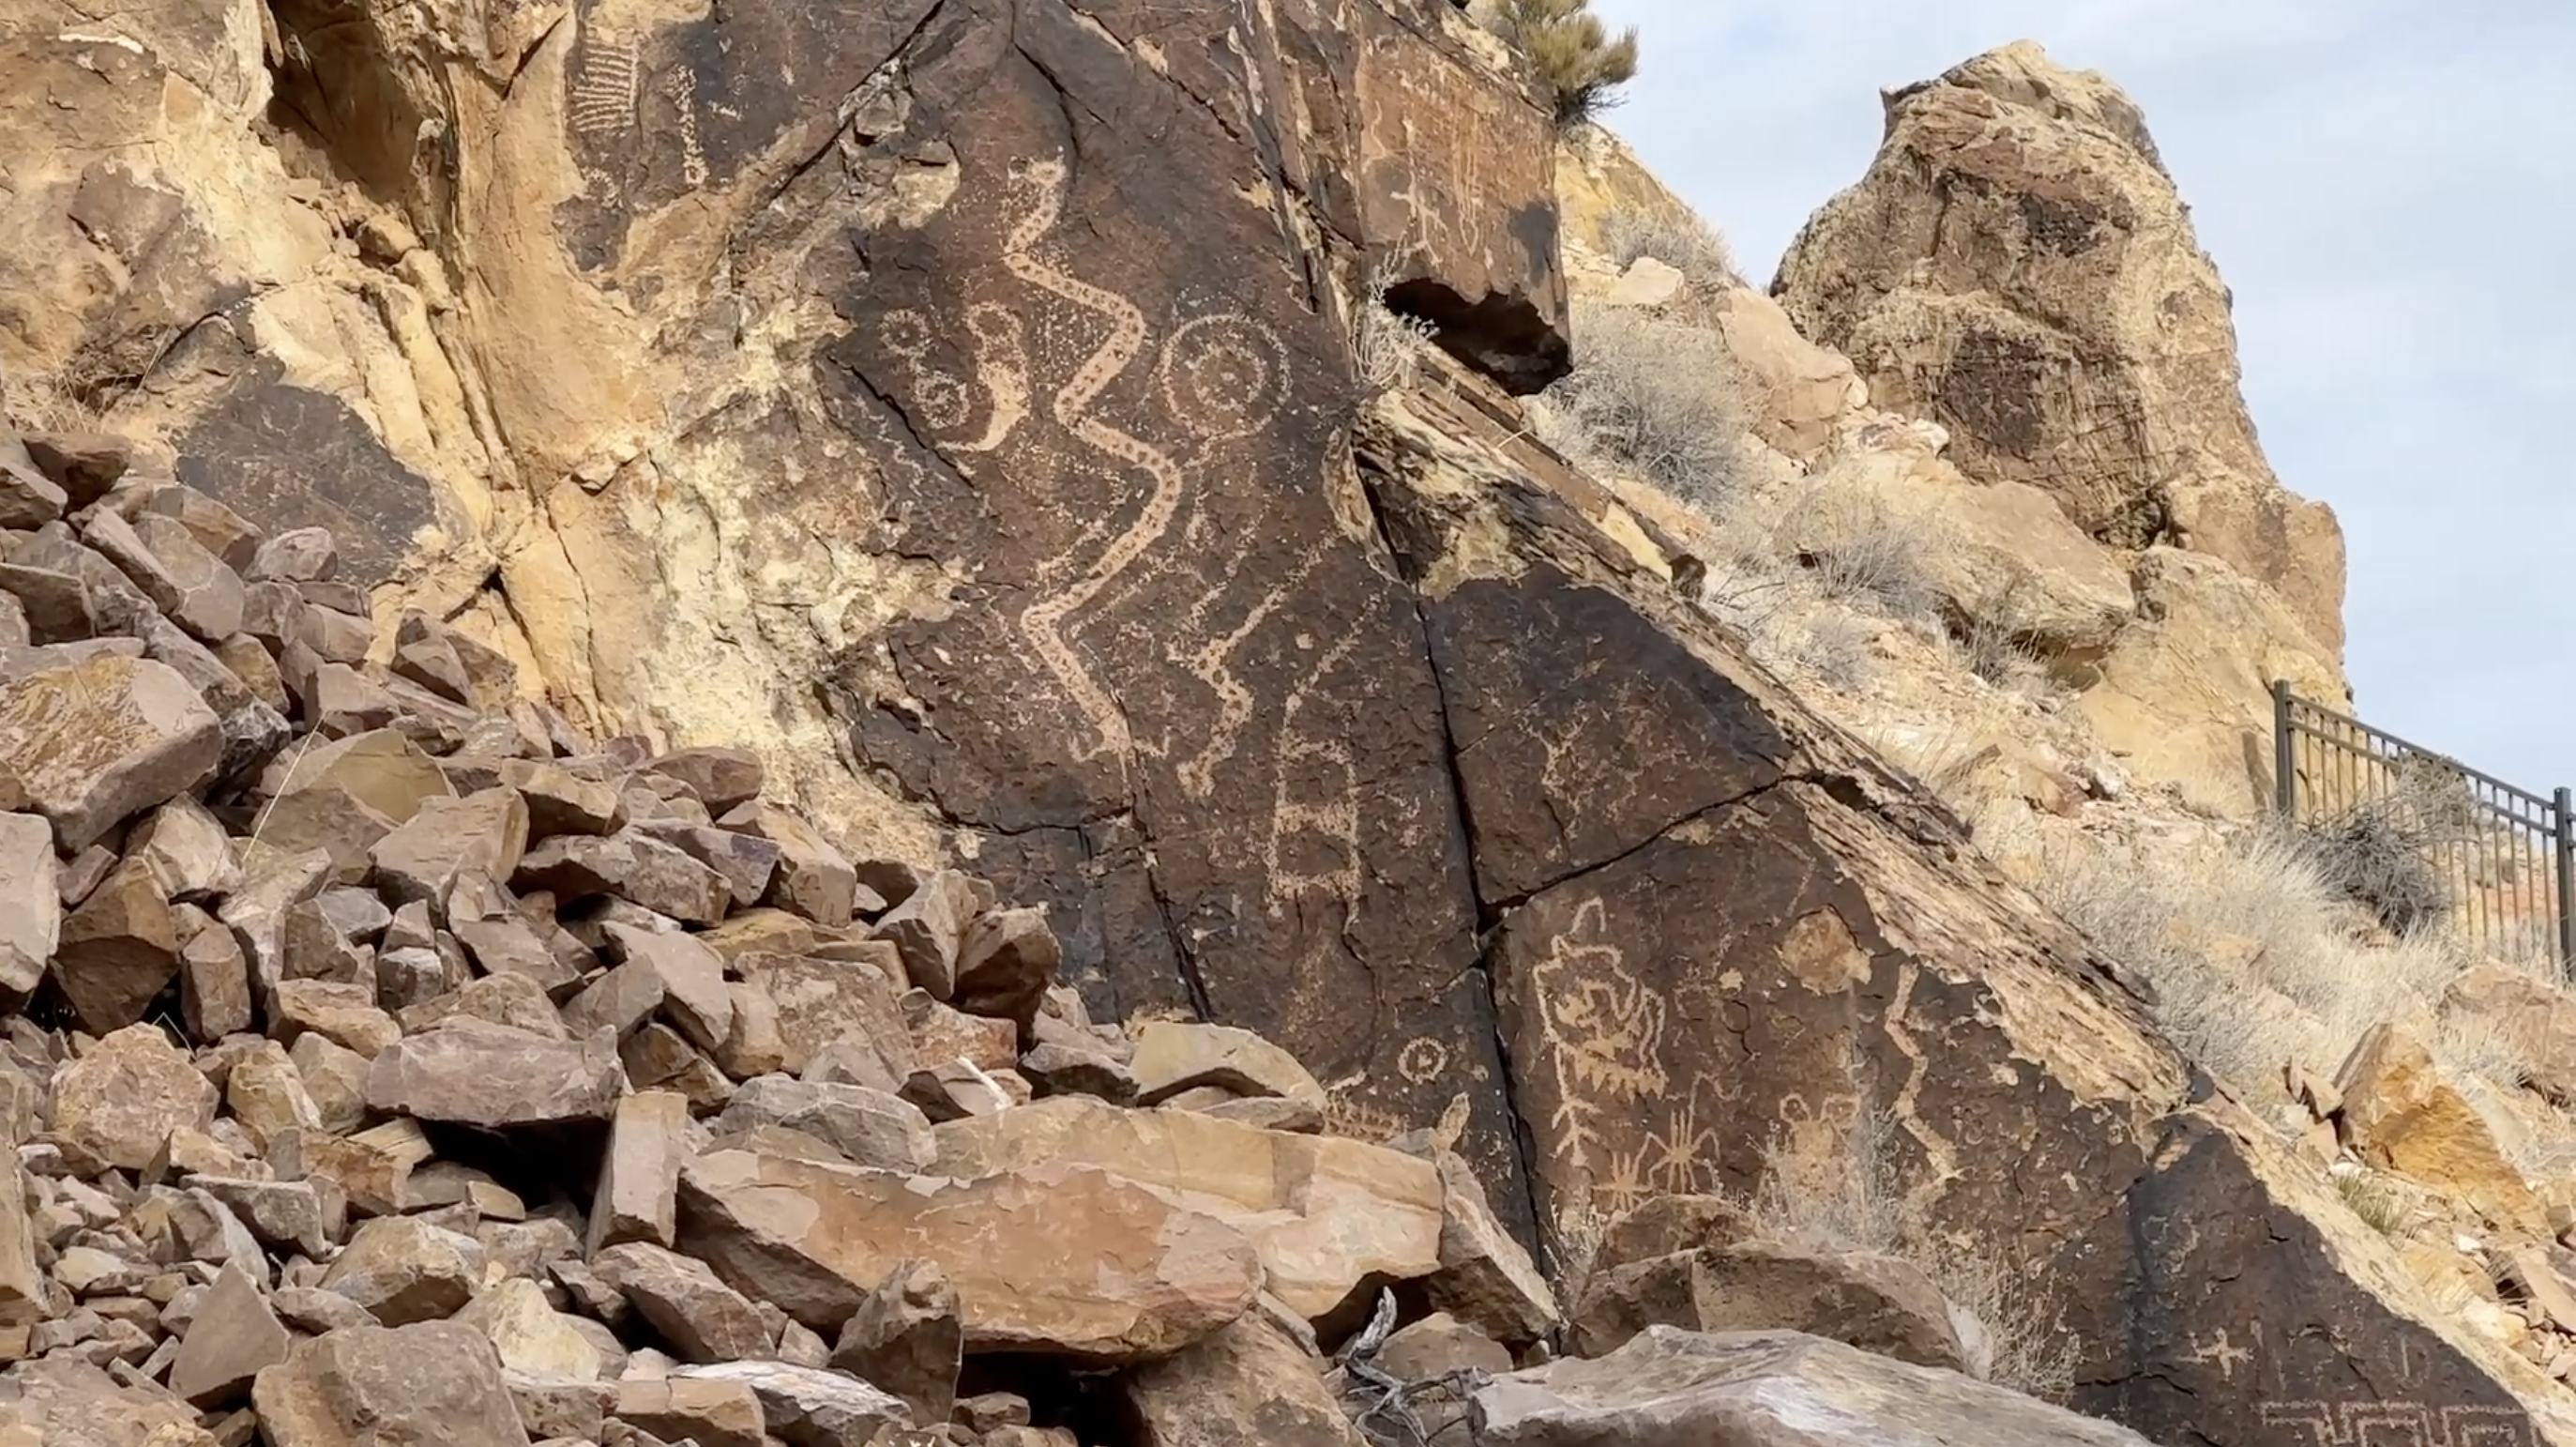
[0, 0, 2576, 1444]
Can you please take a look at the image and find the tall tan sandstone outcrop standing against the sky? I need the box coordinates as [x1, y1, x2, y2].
[1772, 41, 2344, 659]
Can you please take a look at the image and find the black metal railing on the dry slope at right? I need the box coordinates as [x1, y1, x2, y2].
[2272, 679, 2576, 973]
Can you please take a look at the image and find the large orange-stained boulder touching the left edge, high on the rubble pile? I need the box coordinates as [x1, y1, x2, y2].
[0, 654, 224, 852]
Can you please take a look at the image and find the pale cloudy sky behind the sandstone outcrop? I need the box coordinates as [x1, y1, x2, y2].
[1595, 0, 2576, 793]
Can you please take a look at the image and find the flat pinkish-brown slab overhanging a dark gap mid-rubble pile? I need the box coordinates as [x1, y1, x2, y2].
[366, 1022, 626, 1131]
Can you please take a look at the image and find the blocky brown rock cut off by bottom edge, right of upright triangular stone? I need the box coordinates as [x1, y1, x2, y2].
[252, 1321, 528, 1447]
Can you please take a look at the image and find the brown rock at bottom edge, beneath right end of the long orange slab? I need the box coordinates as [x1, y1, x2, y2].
[1123, 1311, 1368, 1447]
